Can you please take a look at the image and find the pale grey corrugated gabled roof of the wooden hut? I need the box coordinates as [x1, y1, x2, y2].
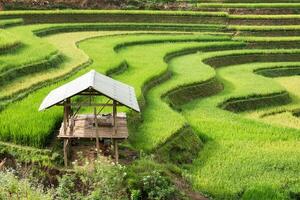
[39, 70, 140, 112]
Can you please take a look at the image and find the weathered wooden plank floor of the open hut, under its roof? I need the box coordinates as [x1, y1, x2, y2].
[58, 113, 128, 139]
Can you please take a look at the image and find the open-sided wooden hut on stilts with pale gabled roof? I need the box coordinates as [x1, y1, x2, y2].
[39, 70, 140, 166]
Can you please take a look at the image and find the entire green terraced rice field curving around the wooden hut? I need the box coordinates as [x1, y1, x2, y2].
[0, 4, 300, 199]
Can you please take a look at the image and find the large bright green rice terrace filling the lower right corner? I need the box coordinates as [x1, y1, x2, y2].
[179, 63, 300, 199]
